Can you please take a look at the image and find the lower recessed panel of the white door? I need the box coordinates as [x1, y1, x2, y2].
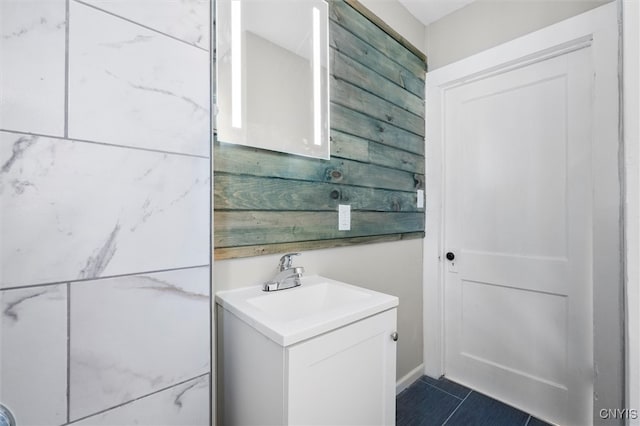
[460, 280, 567, 387]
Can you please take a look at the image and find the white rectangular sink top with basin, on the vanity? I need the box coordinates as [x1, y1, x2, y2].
[216, 275, 398, 346]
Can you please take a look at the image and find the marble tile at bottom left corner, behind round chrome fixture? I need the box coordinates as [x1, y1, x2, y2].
[0, 285, 67, 426]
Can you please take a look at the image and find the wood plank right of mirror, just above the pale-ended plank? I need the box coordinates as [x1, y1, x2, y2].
[331, 103, 424, 155]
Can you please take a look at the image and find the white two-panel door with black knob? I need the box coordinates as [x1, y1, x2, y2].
[443, 46, 594, 424]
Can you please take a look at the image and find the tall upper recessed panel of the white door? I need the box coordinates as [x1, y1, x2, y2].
[459, 74, 567, 257]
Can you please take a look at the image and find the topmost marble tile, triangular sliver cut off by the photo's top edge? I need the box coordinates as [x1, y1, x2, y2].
[76, 0, 210, 50]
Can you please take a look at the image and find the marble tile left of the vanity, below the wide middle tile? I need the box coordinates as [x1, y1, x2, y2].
[70, 267, 210, 424]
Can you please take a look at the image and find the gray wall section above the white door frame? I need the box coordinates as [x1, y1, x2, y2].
[425, 0, 612, 70]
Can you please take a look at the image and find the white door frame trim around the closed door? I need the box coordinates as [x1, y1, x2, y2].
[423, 2, 624, 420]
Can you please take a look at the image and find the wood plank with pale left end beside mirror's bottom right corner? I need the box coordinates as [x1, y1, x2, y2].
[331, 129, 424, 175]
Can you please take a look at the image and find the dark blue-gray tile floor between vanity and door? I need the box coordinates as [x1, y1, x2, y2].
[396, 376, 549, 426]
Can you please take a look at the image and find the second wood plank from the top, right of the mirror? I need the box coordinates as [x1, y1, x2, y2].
[329, 21, 424, 98]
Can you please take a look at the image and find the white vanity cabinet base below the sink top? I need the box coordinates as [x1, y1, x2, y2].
[217, 304, 397, 426]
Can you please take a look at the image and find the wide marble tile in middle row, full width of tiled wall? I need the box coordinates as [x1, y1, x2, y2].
[0, 132, 210, 288]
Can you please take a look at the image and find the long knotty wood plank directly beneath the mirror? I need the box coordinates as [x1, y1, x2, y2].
[214, 143, 424, 191]
